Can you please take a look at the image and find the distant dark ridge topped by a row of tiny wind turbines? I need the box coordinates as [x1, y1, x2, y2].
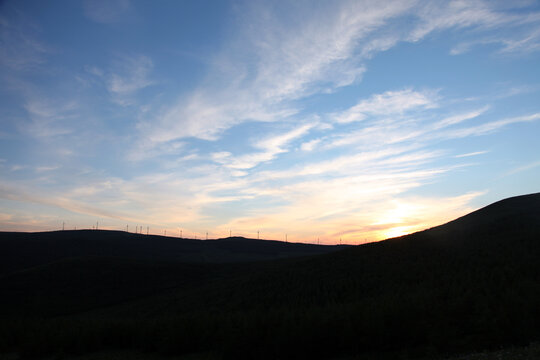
[0, 230, 346, 274]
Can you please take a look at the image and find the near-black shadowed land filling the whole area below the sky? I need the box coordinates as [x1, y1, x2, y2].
[0, 194, 540, 359]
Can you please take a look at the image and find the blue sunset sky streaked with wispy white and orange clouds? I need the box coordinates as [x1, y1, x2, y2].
[0, 0, 540, 244]
